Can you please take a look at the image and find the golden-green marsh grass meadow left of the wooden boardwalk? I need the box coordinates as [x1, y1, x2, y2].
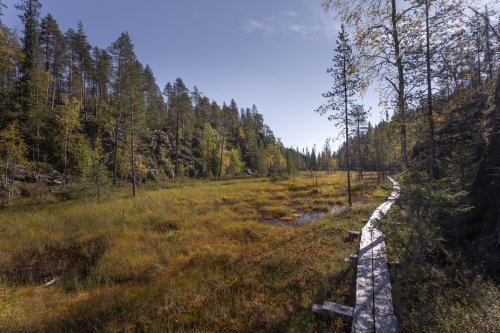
[0, 174, 377, 332]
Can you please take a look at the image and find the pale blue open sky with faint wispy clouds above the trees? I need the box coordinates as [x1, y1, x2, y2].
[1, 0, 381, 149]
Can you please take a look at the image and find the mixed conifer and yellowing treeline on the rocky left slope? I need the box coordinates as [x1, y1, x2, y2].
[0, 0, 312, 198]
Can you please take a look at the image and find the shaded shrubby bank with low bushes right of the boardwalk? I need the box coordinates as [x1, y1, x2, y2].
[379, 169, 500, 333]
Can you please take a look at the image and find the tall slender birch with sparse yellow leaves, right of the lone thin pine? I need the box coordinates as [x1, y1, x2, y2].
[323, 0, 420, 169]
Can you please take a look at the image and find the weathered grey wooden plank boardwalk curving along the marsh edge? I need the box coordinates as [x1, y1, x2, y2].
[312, 177, 399, 333]
